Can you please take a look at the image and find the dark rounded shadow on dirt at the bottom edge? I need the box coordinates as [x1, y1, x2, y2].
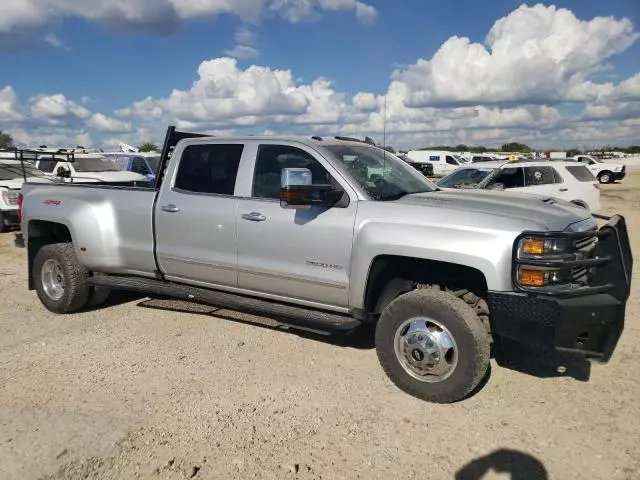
[455, 449, 549, 480]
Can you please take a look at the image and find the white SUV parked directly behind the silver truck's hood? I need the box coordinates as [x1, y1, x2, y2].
[437, 161, 600, 212]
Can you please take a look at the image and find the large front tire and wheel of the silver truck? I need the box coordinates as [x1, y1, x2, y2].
[375, 289, 490, 403]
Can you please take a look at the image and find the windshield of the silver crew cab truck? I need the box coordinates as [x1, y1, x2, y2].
[326, 145, 438, 200]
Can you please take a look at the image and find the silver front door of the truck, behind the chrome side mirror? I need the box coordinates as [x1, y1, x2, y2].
[238, 143, 358, 307]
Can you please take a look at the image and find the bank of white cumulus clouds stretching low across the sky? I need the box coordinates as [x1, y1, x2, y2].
[0, 4, 640, 148]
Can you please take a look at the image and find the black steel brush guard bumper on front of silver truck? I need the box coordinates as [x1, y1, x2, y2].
[488, 215, 633, 363]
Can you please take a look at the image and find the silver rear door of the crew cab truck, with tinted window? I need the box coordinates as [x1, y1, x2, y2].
[154, 142, 245, 287]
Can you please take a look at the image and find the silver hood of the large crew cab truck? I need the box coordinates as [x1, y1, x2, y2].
[397, 189, 595, 230]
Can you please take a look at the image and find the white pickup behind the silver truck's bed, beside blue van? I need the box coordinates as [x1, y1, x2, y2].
[36, 153, 149, 185]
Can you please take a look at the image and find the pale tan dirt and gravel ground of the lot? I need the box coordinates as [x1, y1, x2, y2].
[0, 174, 640, 480]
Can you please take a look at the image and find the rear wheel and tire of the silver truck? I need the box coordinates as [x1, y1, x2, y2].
[33, 243, 90, 313]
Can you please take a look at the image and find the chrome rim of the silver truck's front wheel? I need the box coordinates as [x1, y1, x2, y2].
[393, 317, 458, 383]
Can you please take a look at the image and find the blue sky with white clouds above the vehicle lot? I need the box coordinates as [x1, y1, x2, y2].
[0, 0, 640, 145]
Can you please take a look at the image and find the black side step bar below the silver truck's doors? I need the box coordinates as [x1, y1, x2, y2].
[89, 275, 361, 332]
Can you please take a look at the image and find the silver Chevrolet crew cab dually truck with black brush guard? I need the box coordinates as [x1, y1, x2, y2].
[21, 127, 632, 403]
